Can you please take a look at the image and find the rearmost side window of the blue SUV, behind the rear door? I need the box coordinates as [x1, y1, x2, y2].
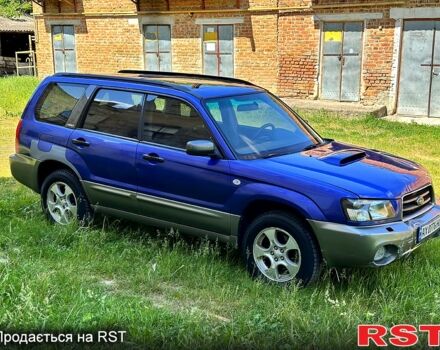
[35, 83, 87, 126]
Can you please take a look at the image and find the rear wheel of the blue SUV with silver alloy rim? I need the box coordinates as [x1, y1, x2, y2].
[41, 170, 93, 225]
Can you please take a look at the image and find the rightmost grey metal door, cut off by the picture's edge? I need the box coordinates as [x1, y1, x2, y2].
[397, 20, 440, 117]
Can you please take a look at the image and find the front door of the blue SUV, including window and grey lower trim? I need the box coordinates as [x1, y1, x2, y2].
[136, 95, 234, 235]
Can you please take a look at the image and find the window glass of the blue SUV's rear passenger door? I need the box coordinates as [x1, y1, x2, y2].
[83, 89, 144, 139]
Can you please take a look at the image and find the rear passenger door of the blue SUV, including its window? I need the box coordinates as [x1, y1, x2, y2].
[69, 88, 144, 211]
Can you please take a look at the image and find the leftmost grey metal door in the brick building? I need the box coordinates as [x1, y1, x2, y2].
[52, 26, 76, 73]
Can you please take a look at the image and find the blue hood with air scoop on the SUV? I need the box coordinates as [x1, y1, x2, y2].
[241, 141, 431, 198]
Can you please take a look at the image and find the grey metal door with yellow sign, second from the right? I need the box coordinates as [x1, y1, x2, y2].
[321, 22, 363, 101]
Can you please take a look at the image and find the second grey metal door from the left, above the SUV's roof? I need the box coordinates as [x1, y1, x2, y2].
[144, 24, 171, 72]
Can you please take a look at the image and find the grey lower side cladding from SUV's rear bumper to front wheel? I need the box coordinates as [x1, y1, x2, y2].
[10, 140, 240, 245]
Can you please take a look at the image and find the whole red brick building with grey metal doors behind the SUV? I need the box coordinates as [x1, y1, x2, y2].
[34, 0, 440, 117]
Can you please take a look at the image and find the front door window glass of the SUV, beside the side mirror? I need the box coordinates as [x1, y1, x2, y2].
[143, 95, 211, 149]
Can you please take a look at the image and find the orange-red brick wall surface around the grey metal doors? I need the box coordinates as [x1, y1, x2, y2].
[34, 0, 440, 105]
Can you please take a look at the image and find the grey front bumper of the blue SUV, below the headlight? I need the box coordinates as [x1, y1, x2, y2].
[309, 205, 440, 267]
